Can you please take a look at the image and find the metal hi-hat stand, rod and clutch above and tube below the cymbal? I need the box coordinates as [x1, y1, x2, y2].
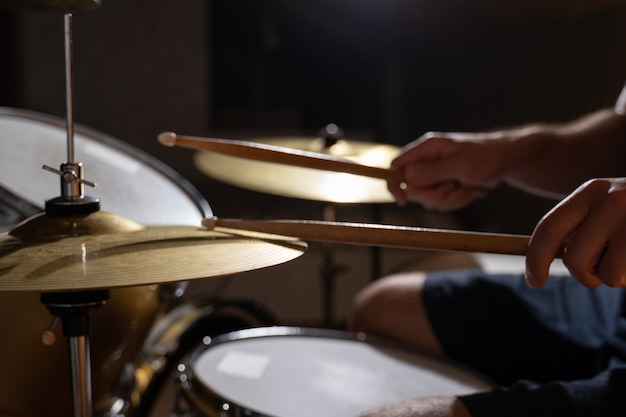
[40, 13, 102, 417]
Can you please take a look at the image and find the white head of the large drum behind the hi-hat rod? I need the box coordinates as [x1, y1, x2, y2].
[0, 108, 212, 226]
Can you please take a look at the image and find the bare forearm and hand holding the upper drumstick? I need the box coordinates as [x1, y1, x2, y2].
[389, 93, 626, 210]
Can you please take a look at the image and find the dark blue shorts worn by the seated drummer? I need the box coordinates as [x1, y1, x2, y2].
[424, 270, 626, 417]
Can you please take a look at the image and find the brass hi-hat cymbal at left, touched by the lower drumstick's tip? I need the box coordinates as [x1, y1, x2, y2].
[0, 211, 306, 292]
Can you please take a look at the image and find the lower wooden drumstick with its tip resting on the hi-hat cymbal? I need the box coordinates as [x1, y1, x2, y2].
[202, 217, 544, 255]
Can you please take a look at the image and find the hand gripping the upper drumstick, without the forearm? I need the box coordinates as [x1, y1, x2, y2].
[388, 132, 502, 211]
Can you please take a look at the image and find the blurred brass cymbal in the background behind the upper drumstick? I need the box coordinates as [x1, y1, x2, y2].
[194, 137, 399, 203]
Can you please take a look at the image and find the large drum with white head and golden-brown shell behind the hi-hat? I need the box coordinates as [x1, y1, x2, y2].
[0, 108, 211, 417]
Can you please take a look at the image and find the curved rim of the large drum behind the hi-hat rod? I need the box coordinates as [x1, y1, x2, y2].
[0, 106, 213, 217]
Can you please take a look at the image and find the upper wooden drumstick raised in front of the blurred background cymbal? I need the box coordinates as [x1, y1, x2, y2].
[158, 132, 404, 182]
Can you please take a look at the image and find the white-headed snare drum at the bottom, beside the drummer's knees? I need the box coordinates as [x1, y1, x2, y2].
[180, 327, 492, 417]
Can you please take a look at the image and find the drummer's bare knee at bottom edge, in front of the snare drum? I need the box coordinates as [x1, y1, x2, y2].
[361, 397, 471, 417]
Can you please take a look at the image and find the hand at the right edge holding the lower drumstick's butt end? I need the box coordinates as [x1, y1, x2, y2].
[526, 178, 626, 287]
